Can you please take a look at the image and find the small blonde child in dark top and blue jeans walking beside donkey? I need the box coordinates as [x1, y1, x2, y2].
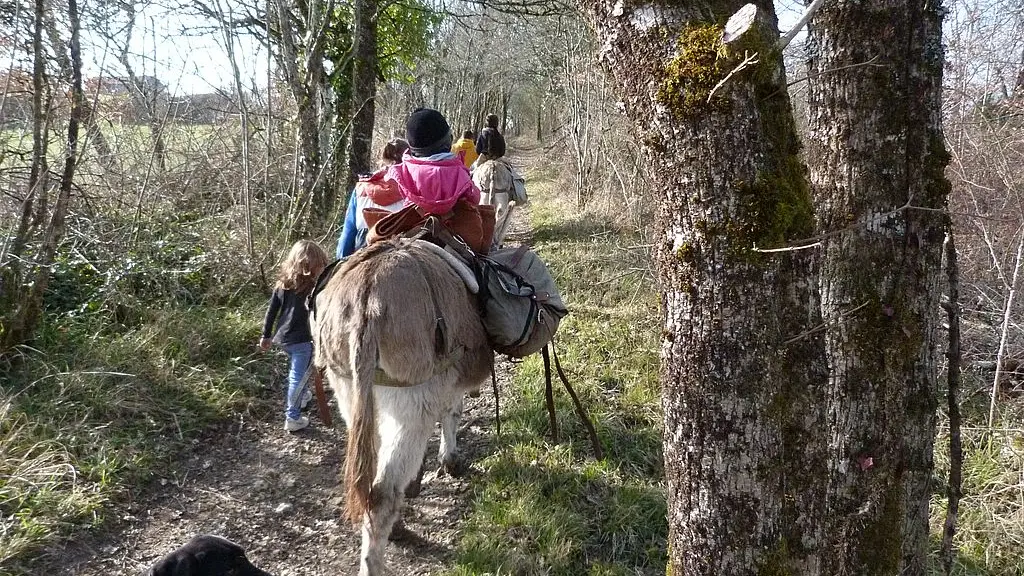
[259, 240, 328, 431]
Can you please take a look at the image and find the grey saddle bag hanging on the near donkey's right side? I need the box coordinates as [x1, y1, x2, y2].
[473, 246, 568, 358]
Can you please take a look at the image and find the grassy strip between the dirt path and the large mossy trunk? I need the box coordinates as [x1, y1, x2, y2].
[450, 168, 668, 575]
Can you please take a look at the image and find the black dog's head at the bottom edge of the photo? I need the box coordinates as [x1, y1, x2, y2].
[146, 534, 271, 576]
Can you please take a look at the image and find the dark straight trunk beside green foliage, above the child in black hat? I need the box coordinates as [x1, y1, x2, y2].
[346, 0, 377, 195]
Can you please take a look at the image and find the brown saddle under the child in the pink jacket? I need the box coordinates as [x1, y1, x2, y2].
[362, 200, 495, 254]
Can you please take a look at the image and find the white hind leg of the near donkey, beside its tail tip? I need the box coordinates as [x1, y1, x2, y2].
[359, 403, 433, 576]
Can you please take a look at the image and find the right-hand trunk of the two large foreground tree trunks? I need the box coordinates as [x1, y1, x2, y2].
[808, 0, 949, 575]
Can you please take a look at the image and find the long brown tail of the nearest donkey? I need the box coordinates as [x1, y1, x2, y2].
[345, 290, 379, 525]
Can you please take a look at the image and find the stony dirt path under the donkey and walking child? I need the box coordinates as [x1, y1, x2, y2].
[37, 152, 544, 576]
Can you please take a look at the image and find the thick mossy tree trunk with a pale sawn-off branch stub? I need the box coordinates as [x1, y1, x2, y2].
[585, 0, 826, 575]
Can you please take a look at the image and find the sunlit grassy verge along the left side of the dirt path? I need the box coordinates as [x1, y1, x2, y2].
[0, 298, 276, 574]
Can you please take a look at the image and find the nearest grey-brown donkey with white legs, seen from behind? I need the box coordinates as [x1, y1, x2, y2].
[310, 235, 494, 576]
